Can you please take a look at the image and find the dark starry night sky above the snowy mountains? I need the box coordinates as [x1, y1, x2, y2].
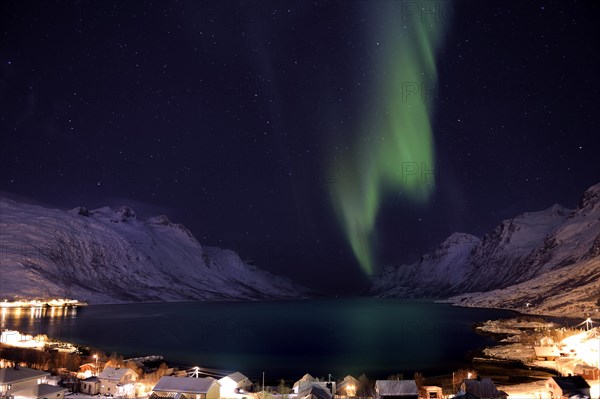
[0, 0, 600, 293]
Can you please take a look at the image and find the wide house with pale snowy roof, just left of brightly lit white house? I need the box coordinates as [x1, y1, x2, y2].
[150, 376, 220, 399]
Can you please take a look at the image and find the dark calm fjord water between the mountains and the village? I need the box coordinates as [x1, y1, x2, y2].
[3, 298, 514, 379]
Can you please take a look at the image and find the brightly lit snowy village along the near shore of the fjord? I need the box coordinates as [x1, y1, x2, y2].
[0, 320, 600, 399]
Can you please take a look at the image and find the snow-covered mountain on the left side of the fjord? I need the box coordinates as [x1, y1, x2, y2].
[0, 198, 309, 303]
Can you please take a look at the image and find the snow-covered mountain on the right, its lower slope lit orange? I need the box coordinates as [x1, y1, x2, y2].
[370, 183, 600, 315]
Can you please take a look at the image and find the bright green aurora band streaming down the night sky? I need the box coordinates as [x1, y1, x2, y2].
[331, 1, 448, 274]
